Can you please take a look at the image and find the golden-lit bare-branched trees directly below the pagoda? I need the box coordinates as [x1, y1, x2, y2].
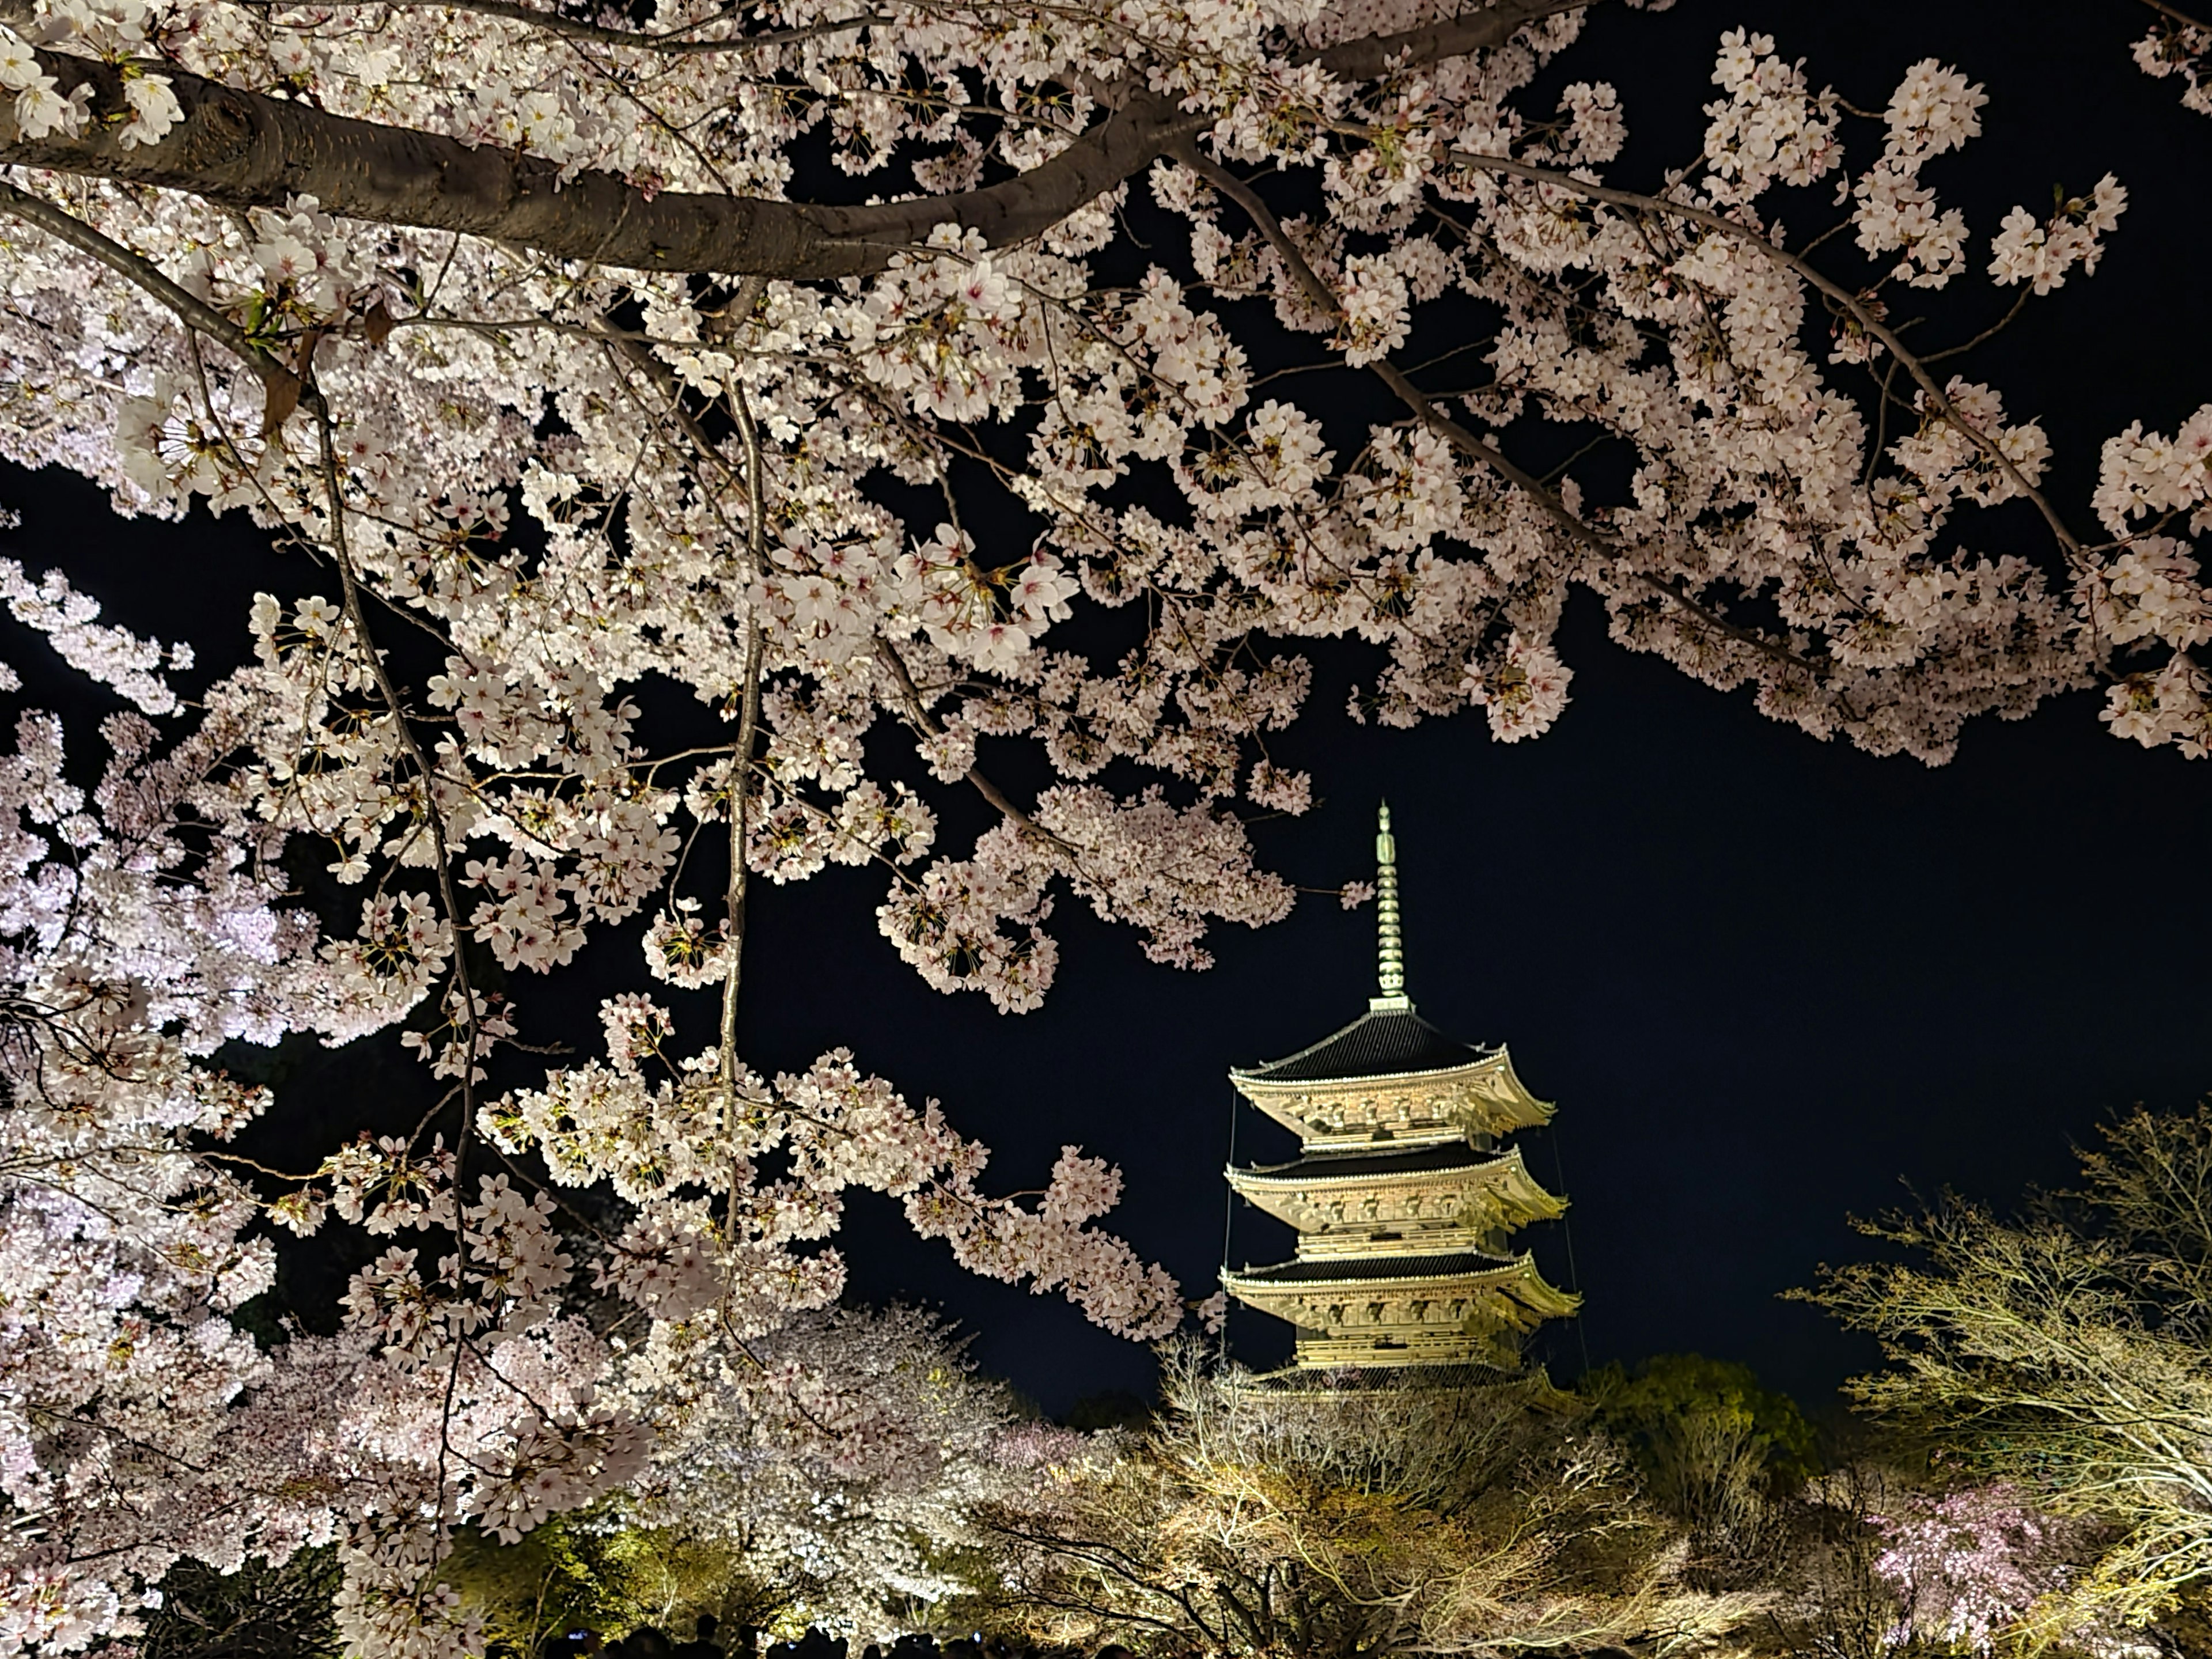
[975, 1349, 1765, 1659]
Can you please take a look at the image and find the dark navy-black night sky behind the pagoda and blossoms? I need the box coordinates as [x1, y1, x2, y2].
[0, 0, 2212, 1411]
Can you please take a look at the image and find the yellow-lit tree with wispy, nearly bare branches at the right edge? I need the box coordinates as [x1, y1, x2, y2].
[1812, 1106, 2212, 1652]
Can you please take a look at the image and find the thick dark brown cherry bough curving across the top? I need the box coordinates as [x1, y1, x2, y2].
[0, 0, 1575, 281]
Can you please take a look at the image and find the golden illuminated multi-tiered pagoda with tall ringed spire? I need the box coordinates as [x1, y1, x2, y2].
[1221, 805, 1580, 1372]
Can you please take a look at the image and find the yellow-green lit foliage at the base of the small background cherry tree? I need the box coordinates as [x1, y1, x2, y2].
[442, 1506, 785, 1659]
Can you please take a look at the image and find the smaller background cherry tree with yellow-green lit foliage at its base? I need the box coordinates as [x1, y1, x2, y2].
[420, 1307, 1062, 1654]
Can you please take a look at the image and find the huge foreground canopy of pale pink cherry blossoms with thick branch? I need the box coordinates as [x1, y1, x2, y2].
[0, 0, 2212, 1654]
